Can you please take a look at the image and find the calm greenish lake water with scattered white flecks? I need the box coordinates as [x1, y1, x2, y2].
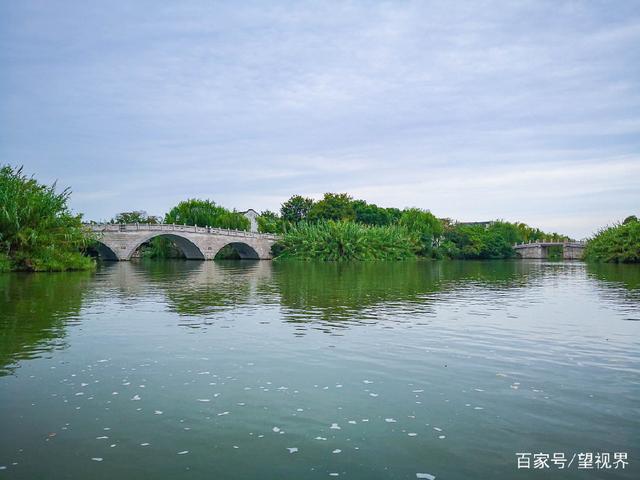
[0, 261, 640, 480]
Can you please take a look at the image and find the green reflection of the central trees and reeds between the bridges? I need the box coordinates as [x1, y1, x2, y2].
[274, 261, 539, 325]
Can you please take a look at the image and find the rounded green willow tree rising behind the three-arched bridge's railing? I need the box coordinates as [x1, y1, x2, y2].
[164, 198, 251, 230]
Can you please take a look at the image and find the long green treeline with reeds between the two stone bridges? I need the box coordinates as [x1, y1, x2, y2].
[258, 193, 568, 260]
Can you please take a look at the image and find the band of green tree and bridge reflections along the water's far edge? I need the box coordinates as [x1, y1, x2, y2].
[0, 261, 640, 373]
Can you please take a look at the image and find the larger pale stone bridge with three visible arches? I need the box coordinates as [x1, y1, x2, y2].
[88, 223, 278, 261]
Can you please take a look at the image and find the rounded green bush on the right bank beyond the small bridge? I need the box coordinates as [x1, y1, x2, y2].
[584, 216, 640, 263]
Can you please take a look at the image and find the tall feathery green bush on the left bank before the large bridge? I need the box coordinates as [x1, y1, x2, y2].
[0, 166, 94, 271]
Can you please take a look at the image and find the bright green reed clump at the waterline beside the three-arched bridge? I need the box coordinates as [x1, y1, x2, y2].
[277, 220, 419, 261]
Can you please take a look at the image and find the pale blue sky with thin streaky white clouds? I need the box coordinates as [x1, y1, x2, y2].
[0, 0, 640, 238]
